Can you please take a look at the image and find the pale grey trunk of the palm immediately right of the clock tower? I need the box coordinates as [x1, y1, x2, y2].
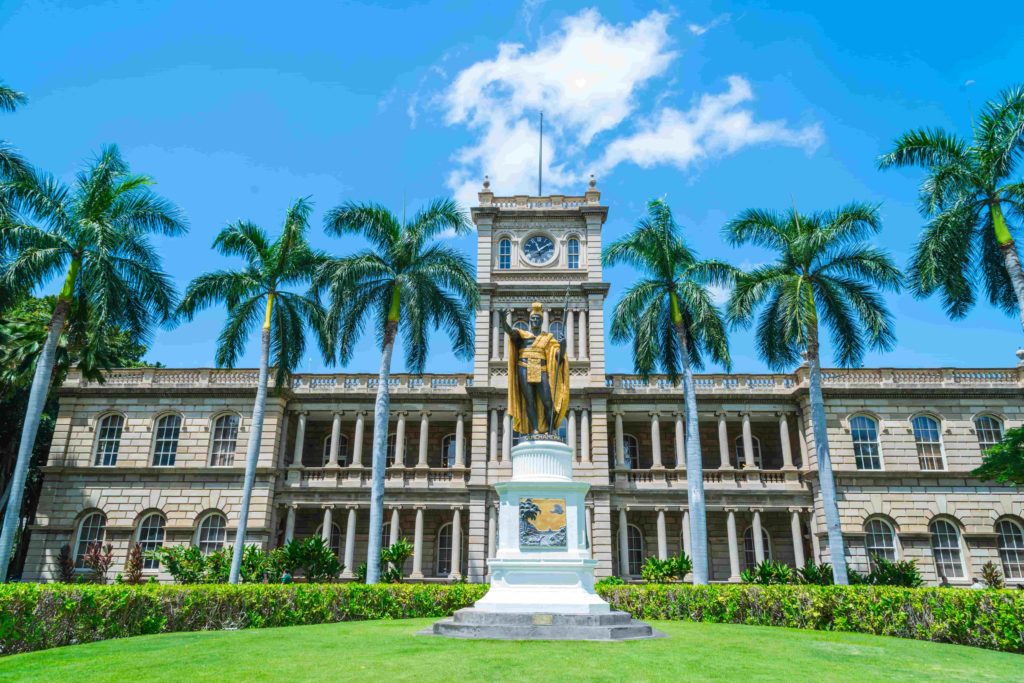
[676, 324, 708, 586]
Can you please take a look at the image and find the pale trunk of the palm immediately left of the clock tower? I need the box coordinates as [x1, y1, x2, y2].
[367, 321, 399, 584]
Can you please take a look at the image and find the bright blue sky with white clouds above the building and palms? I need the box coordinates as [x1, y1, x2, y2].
[0, 0, 1024, 372]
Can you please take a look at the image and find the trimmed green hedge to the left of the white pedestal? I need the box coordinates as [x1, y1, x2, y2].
[0, 584, 487, 655]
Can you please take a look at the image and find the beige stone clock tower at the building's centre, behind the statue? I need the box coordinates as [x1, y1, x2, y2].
[468, 176, 611, 579]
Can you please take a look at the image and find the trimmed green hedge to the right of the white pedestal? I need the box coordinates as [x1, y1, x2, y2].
[598, 585, 1024, 652]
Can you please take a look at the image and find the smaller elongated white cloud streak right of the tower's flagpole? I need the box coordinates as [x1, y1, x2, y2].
[597, 76, 824, 172]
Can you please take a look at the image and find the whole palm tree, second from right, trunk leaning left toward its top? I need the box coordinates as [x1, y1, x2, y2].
[725, 203, 901, 584]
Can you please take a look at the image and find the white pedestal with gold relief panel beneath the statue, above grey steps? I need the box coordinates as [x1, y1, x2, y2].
[474, 440, 610, 614]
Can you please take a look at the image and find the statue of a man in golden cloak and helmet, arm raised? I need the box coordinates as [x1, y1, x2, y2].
[499, 302, 569, 434]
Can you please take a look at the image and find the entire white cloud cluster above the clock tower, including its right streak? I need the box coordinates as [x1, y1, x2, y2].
[440, 9, 823, 205]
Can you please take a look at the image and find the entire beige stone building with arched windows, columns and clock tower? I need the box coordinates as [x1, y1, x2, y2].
[25, 181, 1024, 584]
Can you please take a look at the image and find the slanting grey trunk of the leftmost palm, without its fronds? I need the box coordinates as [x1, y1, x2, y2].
[0, 296, 71, 583]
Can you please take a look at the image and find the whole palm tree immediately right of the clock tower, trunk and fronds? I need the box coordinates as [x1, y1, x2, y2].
[603, 200, 735, 584]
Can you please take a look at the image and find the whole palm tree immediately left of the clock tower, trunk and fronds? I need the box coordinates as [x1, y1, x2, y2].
[315, 200, 478, 584]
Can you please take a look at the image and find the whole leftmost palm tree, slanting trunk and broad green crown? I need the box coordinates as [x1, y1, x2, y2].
[0, 145, 187, 581]
